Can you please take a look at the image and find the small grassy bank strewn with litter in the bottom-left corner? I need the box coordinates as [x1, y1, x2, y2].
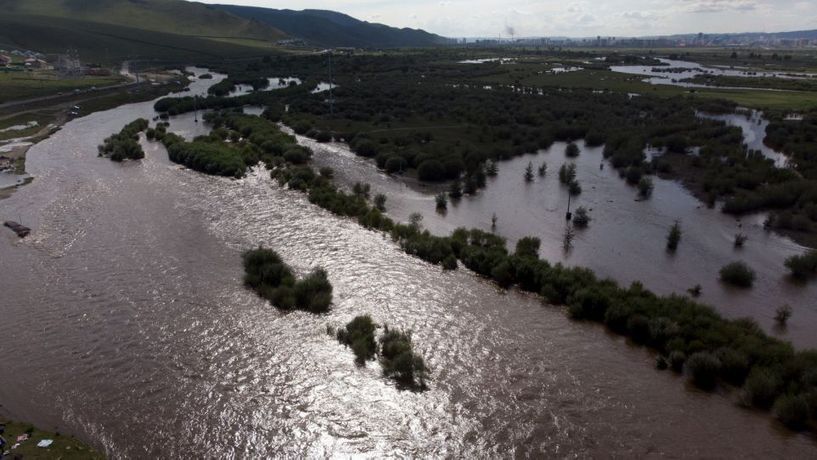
[0, 418, 105, 460]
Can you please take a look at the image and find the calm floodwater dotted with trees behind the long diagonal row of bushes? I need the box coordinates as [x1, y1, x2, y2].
[299, 135, 817, 347]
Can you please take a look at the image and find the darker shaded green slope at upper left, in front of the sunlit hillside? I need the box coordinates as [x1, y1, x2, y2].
[0, 15, 269, 64]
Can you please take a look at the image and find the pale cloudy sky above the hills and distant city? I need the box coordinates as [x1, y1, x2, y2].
[199, 0, 817, 37]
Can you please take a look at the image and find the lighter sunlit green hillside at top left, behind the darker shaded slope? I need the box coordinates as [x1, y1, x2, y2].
[0, 0, 284, 42]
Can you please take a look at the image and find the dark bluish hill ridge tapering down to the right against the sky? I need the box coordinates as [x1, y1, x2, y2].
[217, 5, 447, 48]
